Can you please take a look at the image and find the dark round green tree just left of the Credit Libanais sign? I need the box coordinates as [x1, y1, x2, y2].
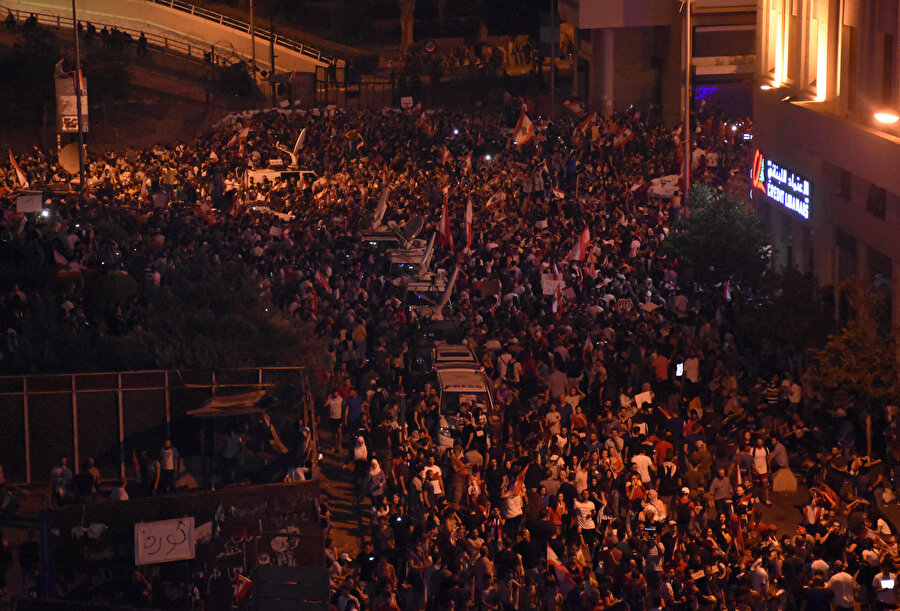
[663, 184, 772, 288]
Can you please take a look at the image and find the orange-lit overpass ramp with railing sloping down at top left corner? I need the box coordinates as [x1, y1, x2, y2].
[0, 0, 344, 74]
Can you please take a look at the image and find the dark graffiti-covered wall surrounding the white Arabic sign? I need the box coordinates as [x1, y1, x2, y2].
[41, 480, 327, 609]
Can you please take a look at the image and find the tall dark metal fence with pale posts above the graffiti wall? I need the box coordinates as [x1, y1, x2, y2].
[0, 367, 312, 483]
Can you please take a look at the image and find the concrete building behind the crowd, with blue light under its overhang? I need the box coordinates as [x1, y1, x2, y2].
[558, 0, 757, 125]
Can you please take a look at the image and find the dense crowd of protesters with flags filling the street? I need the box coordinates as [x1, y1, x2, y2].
[0, 98, 900, 611]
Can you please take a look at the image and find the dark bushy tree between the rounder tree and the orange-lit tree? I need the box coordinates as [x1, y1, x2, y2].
[741, 267, 832, 349]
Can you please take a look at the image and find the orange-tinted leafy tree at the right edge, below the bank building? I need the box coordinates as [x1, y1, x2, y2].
[809, 285, 900, 417]
